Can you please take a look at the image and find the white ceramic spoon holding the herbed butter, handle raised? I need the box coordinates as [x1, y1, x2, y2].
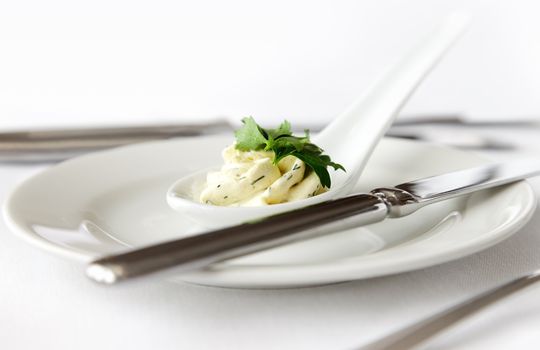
[167, 14, 468, 227]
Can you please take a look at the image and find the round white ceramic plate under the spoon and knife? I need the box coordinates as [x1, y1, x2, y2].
[4, 136, 536, 288]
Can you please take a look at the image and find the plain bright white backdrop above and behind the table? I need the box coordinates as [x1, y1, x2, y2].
[0, 0, 540, 128]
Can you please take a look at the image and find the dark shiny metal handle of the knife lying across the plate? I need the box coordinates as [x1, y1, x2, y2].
[86, 194, 388, 284]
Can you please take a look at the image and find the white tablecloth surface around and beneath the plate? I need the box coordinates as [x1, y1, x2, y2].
[0, 123, 540, 349]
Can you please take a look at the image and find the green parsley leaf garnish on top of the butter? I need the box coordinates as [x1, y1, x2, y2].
[234, 117, 345, 188]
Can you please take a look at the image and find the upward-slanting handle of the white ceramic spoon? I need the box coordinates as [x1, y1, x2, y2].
[314, 13, 468, 185]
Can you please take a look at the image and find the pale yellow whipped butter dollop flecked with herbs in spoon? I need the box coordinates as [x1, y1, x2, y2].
[199, 144, 326, 206]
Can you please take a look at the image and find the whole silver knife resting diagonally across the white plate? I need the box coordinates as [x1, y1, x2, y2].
[86, 160, 540, 284]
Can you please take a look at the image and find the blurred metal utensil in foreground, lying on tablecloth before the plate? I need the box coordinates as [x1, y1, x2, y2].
[359, 270, 540, 350]
